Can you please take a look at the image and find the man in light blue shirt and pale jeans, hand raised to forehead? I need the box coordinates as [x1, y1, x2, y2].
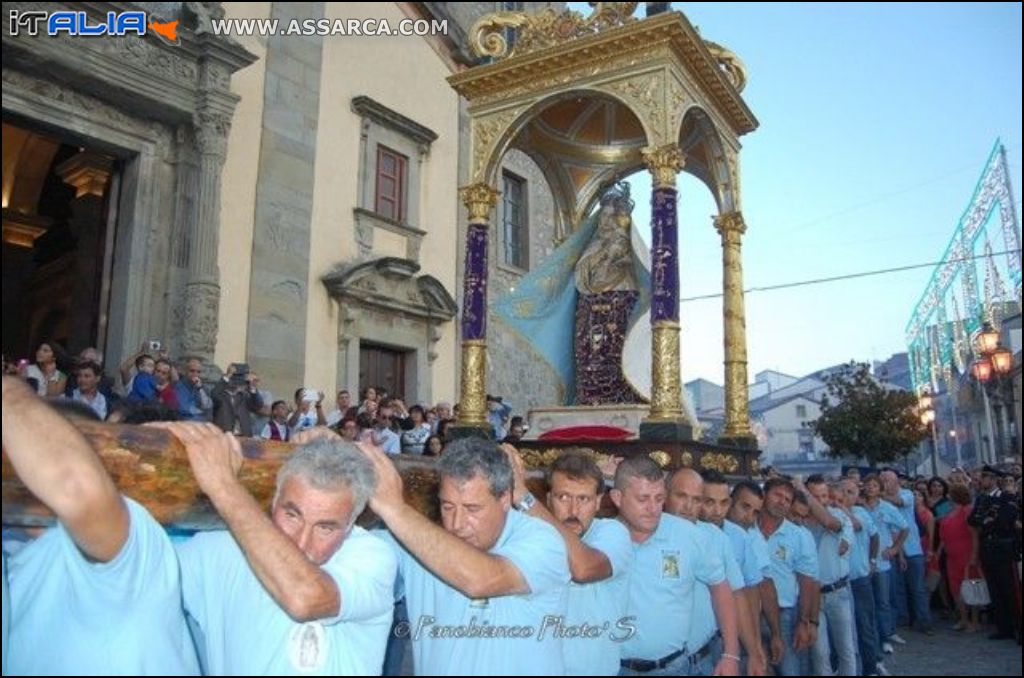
[807, 474, 857, 676]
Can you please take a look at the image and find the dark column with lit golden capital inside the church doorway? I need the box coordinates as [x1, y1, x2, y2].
[56, 151, 114, 351]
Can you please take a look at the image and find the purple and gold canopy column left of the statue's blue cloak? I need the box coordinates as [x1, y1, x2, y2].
[458, 182, 499, 433]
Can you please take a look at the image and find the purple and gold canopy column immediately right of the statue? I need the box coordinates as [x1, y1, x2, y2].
[640, 143, 693, 441]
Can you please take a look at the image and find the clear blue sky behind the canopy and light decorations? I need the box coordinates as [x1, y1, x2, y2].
[573, 2, 1022, 383]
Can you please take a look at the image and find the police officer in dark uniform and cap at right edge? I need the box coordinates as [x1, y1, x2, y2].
[968, 466, 1020, 643]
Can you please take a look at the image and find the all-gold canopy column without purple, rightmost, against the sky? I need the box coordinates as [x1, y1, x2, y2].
[715, 212, 757, 448]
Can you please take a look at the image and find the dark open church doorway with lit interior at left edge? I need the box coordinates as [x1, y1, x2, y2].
[3, 116, 120, 361]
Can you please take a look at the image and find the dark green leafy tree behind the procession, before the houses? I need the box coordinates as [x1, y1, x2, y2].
[810, 363, 929, 467]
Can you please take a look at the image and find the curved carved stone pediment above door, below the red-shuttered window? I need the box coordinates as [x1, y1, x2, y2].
[321, 257, 459, 322]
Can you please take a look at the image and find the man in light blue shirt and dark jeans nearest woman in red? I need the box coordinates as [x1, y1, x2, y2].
[881, 471, 935, 635]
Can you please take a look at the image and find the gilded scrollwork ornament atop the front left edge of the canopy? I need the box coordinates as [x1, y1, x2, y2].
[469, 2, 639, 59]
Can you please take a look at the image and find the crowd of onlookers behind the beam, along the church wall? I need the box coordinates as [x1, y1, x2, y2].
[4, 341, 526, 456]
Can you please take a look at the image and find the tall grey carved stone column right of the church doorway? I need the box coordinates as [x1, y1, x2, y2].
[181, 107, 230, 365]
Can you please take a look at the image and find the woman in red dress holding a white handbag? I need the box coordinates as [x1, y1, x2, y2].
[939, 484, 985, 633]
